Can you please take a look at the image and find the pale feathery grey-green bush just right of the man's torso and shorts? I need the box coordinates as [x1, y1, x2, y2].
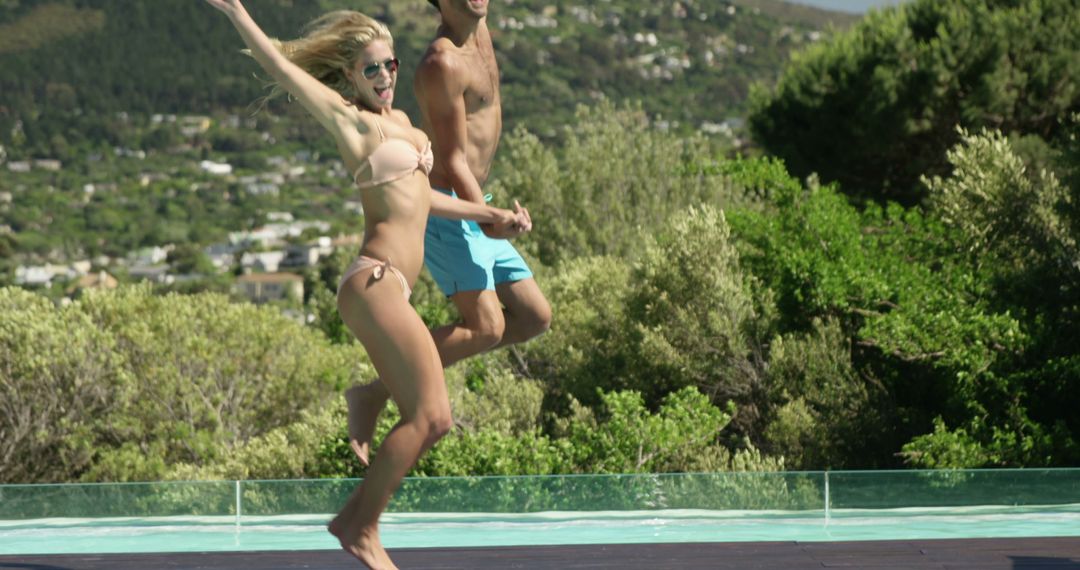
[490, 103, 734, 266]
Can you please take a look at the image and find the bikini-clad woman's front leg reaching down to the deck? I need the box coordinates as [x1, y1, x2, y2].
[330, 274, 453, 568]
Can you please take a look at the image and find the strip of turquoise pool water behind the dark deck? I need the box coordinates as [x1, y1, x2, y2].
[0, 505, 1080, 555]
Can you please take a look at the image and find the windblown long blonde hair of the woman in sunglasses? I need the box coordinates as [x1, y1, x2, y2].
[245, 10, 394, 108]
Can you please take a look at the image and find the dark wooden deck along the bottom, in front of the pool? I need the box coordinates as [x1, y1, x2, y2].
[0, 538, 1080, 570]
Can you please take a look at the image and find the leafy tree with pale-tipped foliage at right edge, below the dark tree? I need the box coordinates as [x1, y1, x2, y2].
[904, 126, 1080, 467]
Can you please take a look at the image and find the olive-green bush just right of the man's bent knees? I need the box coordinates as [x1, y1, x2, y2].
[523, 207, 768, 431]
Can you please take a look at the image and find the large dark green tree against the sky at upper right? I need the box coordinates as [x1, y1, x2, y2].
[750, 0, 1080, 204]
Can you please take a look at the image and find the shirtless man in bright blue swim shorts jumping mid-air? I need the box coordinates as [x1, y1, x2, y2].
[346, 0, 551, 464]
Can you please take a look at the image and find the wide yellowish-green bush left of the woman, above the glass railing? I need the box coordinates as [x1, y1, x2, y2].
[0, 286, 374, 483]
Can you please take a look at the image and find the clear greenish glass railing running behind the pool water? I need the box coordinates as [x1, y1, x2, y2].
[0, 469, 1080, 520]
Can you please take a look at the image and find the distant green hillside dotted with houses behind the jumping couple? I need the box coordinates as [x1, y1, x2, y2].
[0, 0, 853, 267]
